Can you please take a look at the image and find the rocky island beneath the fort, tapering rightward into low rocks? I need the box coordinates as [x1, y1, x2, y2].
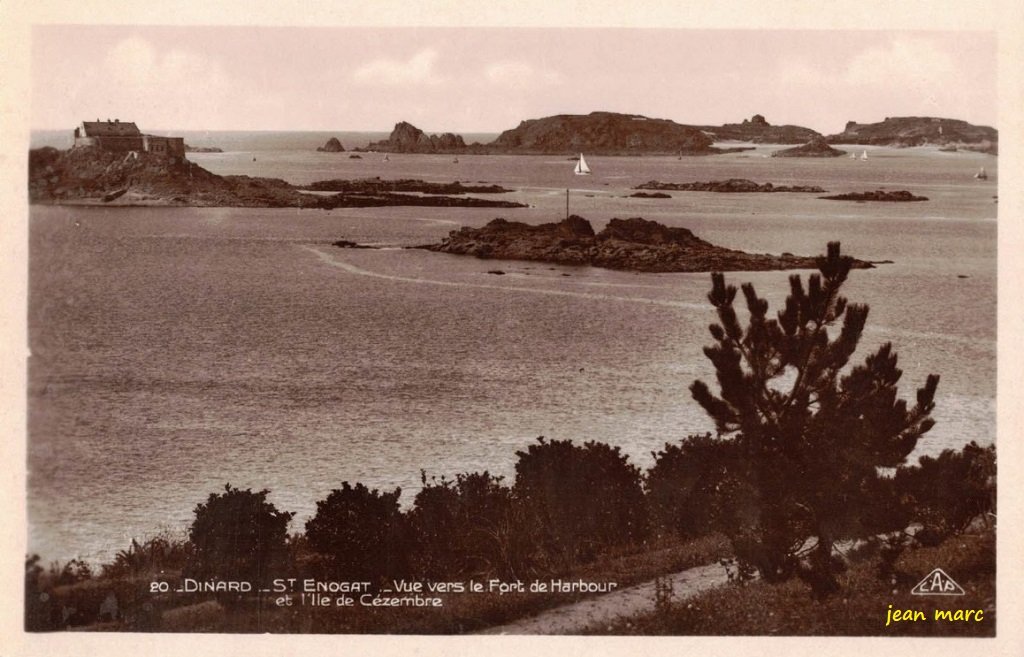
[29, 146, 525, 210]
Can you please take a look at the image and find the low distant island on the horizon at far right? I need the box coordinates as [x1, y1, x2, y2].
[827, 117, 999, 150]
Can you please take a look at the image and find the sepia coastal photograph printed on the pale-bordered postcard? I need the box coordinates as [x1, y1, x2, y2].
[4, 1, 1019, 654]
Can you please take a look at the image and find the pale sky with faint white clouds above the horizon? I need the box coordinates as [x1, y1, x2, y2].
[30, 25, 998, 134]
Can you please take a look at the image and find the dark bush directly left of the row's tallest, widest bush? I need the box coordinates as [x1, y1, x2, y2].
[408, 472, 520, 579]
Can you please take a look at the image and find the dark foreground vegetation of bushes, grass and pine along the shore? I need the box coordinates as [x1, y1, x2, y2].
[26, 244, 995, 633]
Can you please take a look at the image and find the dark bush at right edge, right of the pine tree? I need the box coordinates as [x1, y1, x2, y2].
[895, 441, 995, 545]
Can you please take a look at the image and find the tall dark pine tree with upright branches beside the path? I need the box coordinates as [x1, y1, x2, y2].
[690, 243, 939, 594]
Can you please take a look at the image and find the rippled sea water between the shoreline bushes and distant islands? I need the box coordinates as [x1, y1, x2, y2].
[28, 141, 997, 561]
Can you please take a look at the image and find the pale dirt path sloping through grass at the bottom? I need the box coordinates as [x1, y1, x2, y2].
[479, 564, 728, 634]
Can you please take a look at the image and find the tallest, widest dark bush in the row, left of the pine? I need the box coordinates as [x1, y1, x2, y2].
[513, 437, 648, 568]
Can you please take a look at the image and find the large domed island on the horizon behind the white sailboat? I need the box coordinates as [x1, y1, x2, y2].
[488, 112, 726, 156]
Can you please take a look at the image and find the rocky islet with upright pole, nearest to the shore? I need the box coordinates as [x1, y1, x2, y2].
[421, 215, 872, 272]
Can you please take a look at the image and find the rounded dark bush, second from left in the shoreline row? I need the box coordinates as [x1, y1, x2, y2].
[306, 481, 409, 580]
